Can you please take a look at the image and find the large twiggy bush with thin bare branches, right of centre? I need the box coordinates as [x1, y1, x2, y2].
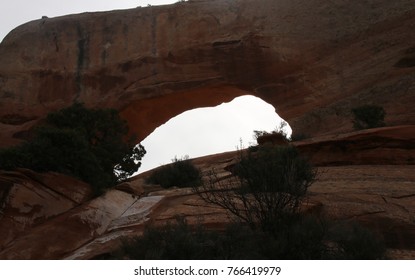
[194, 145, 316, 233]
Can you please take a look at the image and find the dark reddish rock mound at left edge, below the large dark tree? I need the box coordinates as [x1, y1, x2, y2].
[0, 169, 91, 248]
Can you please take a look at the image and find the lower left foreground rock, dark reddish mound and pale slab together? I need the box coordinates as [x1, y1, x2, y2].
[0, 167, 226, 259]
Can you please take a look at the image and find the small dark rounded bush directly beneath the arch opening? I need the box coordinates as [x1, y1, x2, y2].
[147, 157, 202, 188]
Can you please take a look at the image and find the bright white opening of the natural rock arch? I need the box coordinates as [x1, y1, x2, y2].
[138, 95, 291, 173]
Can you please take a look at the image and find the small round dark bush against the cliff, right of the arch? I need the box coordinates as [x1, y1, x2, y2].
[352, 105, 386, 130]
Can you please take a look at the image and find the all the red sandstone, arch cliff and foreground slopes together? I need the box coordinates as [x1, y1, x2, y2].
[0, 0, 415, 259]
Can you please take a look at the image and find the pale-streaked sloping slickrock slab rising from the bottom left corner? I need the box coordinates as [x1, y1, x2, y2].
[0, 187, 162, 259]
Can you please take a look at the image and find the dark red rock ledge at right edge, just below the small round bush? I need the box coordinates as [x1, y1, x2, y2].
[295, 125, 415, 166]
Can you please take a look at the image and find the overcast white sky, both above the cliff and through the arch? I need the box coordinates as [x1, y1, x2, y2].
[0, 0, 290, 172]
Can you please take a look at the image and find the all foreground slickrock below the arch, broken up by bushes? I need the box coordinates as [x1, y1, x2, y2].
[0, 126, 415, 259]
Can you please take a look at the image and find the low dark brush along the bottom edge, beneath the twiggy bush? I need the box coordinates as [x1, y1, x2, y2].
[118, 219, 306, 260]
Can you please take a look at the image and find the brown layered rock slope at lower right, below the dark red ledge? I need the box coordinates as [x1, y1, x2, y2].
[310, 165, 415, 250]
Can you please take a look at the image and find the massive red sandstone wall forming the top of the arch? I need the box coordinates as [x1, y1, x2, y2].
[0, 0, 415, 146]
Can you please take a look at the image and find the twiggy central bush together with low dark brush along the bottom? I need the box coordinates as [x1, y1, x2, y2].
[114, 145, 384, 259]
